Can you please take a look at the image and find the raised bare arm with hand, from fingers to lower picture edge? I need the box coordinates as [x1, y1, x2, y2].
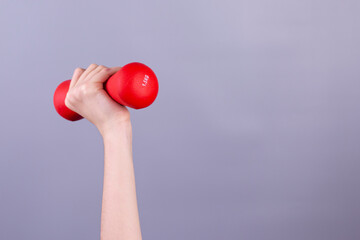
[65, 64, 142, 240]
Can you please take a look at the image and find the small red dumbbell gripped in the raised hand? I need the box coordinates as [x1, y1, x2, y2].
[53, 62, 159, 121]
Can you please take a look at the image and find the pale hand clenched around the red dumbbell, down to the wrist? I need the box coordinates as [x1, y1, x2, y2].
[65, 63, 130, 135]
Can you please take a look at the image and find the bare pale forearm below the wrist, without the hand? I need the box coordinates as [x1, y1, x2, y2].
[101, 121, 141, 240]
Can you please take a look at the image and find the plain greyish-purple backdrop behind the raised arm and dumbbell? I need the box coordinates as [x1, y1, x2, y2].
[0, 0, 360, 240]
